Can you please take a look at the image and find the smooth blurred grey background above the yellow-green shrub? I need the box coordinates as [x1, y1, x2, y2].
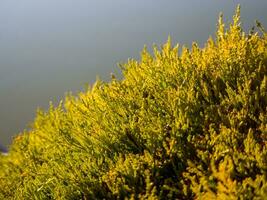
[0, 0, 267, 146]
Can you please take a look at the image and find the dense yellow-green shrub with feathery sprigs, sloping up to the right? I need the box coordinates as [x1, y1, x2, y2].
[0, 9, 267, 199]
